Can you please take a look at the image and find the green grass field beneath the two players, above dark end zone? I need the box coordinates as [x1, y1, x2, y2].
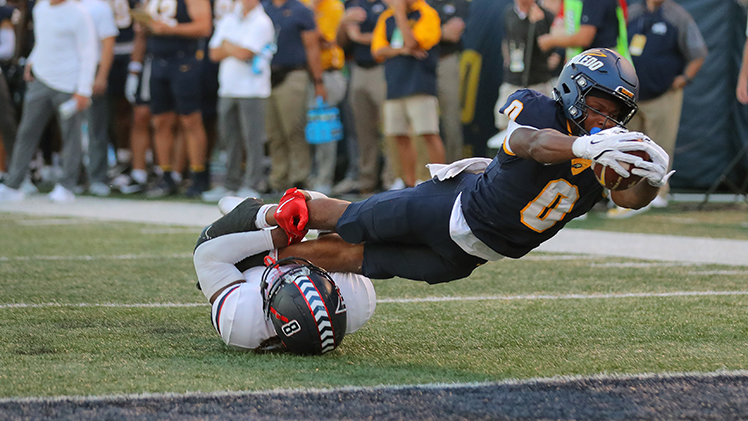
[0, 210, 748, 397]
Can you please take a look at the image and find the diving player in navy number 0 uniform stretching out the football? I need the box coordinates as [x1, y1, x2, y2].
[256, 49, 672, 283]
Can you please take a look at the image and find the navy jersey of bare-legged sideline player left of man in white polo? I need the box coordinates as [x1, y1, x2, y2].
[146, 0, 198, 58]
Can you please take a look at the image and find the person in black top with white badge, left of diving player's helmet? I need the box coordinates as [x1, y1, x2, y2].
[494, 0, 554, 133]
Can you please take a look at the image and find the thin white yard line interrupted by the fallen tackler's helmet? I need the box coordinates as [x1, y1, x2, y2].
[0, 291, 748, 309]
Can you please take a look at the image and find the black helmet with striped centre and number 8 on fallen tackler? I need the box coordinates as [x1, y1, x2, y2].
[260, 257, 347, 355]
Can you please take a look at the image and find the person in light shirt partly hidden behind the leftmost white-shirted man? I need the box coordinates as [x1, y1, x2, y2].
[81, 0, 119, 196]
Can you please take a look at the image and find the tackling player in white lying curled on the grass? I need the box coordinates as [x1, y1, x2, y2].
[194, 197, 376, 354]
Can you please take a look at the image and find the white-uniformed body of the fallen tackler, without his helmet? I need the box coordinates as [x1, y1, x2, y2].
[194, 192, 377, 351]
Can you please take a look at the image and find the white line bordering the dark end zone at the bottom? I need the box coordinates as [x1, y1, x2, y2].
[0, 370, 748, 404]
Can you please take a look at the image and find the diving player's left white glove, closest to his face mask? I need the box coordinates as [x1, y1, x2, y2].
[571, 127, 654, 177]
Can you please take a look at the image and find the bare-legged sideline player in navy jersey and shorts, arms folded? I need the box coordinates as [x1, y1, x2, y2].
[146, 0, 213, 197]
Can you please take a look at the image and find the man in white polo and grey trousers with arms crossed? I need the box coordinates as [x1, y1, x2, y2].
[202, 0, 275, 202]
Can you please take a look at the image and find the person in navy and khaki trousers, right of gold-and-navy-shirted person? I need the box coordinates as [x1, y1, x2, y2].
[427, 0, 470, 162]
